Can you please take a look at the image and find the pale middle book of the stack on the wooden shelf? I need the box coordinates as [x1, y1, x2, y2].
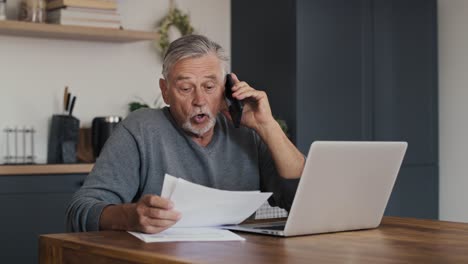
[47, 8, 120, 24]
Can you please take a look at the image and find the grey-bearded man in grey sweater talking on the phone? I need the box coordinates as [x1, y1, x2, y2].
[67, 35, 304, 233]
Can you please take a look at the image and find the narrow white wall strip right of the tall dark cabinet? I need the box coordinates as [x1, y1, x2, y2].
[438, 0, 468, 222]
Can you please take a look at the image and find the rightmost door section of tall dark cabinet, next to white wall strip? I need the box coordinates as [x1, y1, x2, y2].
[372, 0, 439, 219]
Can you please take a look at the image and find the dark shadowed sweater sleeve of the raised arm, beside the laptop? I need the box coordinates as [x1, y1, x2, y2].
[256, 135, 299, 212]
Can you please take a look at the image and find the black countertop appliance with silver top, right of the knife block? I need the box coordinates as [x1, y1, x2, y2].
[91, 116, 122, 158]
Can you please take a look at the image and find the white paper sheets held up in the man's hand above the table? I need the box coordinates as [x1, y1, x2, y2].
[161, 174, 272, 228]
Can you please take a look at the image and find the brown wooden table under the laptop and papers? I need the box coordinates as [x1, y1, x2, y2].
[39, 217, 468, 264]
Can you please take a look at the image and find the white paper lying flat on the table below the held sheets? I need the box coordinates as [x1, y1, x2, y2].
[128, 227, 245, 243]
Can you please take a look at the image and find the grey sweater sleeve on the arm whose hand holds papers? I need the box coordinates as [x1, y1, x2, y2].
[66, 124, 140, 232]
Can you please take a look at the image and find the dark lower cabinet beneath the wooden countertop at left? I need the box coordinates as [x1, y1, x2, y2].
[0, 174, 86, 263]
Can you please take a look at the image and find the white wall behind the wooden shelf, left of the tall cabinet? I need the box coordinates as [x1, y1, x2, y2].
[0, 0, 231, 163]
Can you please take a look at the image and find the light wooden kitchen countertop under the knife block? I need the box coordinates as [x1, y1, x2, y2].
[0, 163, 94, 176]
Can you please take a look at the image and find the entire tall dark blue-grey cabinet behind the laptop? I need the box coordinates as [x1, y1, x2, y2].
[231, 0, 438, 219]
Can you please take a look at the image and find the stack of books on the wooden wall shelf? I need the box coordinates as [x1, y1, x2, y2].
[47, 0, 121, 28]
